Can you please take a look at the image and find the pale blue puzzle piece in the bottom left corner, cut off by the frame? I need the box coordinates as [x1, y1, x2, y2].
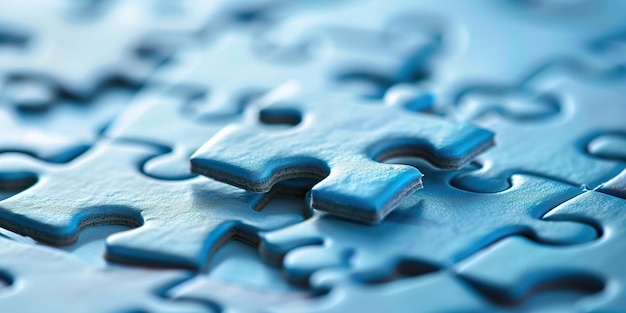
[0, 237, 210, 313]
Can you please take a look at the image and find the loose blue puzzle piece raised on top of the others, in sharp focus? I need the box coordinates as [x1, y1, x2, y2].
[191, 86, 493, 222]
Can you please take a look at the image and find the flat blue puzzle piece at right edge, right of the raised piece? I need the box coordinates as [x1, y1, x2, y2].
[455, 68, 626, 192]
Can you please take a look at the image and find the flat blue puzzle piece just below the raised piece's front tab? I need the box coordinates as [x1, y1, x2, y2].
[262, 158, 596, 282]
